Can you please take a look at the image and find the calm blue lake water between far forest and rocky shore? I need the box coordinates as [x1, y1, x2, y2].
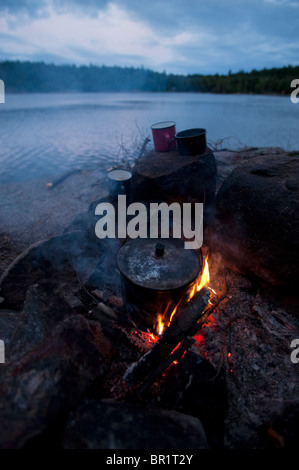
[0, 93, 299, 184]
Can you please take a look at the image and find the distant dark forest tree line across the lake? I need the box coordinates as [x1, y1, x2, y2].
[0, 60, 299, 94]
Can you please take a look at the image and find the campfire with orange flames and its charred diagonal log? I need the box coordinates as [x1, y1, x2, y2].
[118, 256, 221, 392]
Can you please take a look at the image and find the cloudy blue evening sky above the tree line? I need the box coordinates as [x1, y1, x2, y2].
[0, 0, 299, 75]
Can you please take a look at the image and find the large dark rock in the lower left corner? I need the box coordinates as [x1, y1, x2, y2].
[0, 286, 104, 449]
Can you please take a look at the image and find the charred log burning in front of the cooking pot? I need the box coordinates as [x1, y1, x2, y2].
[124, 288, 210, 385]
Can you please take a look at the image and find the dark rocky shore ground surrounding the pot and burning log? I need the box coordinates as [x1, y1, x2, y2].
[0, 148, 299, 449]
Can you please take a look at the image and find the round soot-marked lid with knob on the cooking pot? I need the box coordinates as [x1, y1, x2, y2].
[117, 238, 201, 291]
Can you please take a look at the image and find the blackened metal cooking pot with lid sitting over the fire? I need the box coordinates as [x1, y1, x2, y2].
[117, 238, 202, 327]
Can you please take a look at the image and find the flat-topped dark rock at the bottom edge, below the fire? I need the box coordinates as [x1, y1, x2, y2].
[63, 399, 208, 450]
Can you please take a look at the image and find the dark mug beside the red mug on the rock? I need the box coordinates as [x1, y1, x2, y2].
[175, 129, 207, 155]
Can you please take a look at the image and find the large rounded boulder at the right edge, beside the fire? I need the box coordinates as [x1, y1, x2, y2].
[209, 155, 299, 290]
